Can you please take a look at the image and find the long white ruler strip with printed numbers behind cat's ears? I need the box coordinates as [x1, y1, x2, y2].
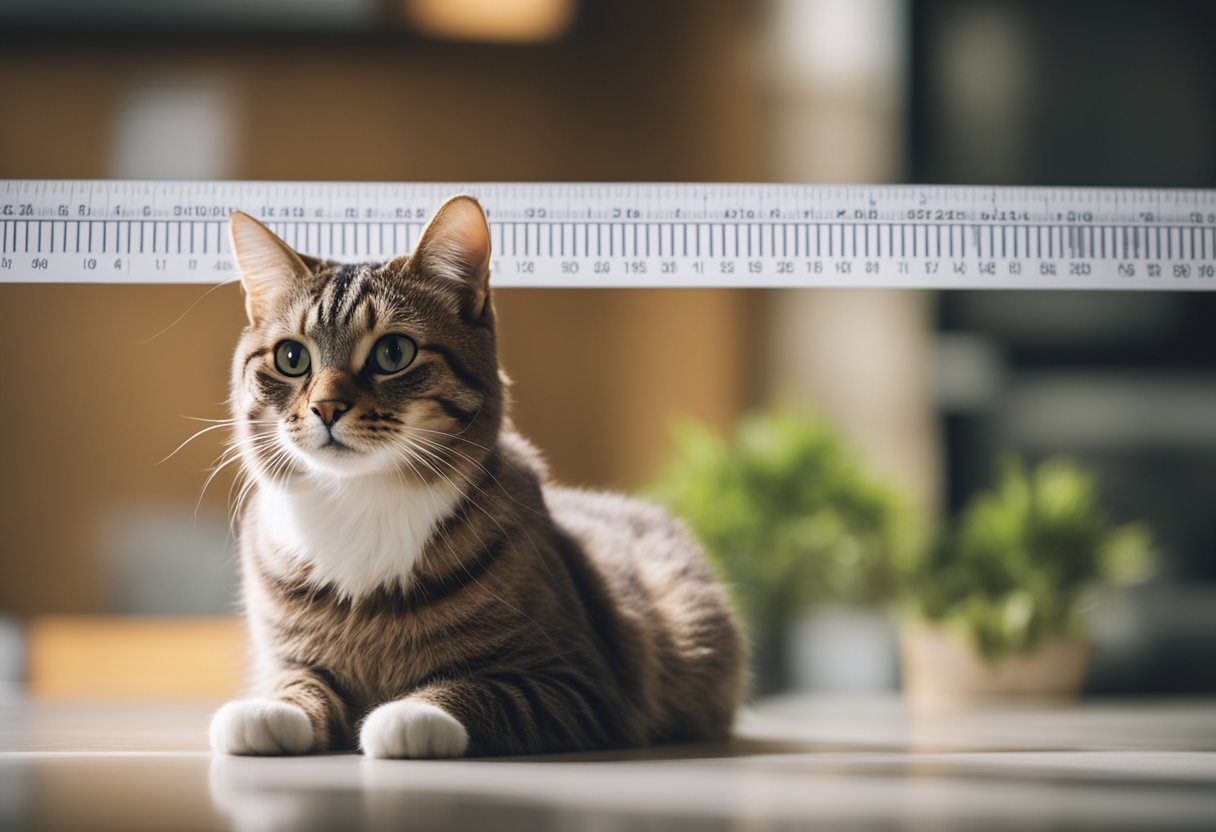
[0, 180, 1216, 289]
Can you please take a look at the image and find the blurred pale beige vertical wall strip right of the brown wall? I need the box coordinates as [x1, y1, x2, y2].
[761, 0, 941, 518]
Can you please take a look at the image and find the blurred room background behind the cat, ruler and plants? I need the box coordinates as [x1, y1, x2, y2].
[0, 0, 1216, 696]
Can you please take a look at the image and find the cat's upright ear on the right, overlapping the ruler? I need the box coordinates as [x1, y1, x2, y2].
[410, 196, 490, 319]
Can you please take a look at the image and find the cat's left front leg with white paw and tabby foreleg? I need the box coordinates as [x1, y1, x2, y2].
[210, 670, 345, 755]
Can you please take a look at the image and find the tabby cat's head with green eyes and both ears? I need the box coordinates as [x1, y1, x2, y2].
[229, 196, 502, 482]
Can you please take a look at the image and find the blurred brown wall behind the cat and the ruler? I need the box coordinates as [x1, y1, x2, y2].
[0, 0, 759, 614]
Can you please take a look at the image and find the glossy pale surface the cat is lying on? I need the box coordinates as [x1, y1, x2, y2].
[0, 698, 1216, 832]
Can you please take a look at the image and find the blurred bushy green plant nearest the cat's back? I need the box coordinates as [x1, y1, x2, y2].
[653, 411, 908, 693]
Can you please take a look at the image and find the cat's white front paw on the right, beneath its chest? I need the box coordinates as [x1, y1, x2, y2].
[359, 699, 468, 758]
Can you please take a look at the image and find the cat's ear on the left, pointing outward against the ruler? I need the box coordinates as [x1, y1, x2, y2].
[229, 210, 316, 325]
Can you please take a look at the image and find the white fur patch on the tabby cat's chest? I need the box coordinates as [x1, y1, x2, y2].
[254, 476, 461, 598]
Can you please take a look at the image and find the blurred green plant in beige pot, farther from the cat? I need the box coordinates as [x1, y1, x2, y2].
[901, 457, 1154, 702]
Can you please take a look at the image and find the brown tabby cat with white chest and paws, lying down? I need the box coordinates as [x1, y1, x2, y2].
[210, 196, 745, 758]
